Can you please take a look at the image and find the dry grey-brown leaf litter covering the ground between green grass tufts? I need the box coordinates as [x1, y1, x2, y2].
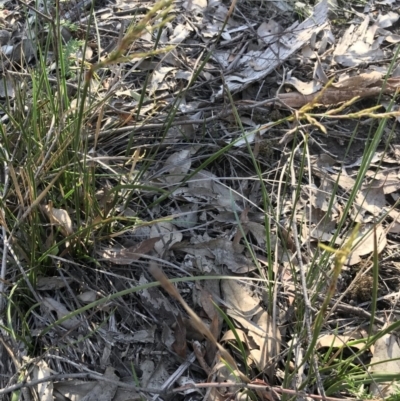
[0, 0, 400, 400]
